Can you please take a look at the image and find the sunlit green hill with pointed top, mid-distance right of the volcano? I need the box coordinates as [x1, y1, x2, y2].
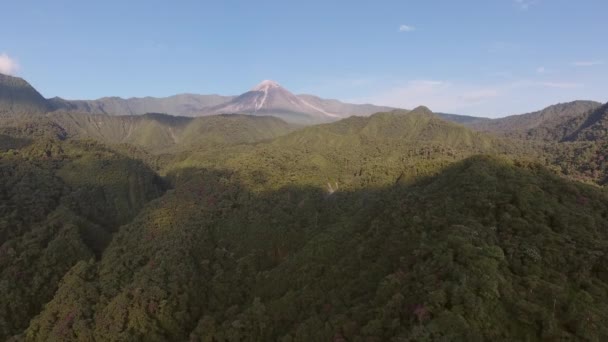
[169, 107, 527, 192]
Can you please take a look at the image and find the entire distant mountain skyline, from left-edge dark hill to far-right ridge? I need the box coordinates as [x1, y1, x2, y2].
[0, 74, 602, 135]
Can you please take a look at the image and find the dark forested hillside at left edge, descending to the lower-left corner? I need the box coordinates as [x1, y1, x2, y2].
[0, 136, 165, 340]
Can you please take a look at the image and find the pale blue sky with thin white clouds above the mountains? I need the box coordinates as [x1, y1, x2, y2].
[0, 0, 608, 117]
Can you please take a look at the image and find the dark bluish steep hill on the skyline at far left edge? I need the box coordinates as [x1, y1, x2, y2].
[0, 74, 50, 117]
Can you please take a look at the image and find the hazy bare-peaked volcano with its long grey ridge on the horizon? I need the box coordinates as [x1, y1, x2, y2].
[48, 80, 402, 124]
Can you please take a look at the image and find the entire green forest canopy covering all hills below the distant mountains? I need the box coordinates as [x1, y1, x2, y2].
[0, 74, 608, 341]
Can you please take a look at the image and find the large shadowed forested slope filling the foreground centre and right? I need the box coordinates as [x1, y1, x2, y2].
[16, 157, 608, 342]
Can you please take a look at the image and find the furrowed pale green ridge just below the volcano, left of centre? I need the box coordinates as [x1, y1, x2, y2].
[49, 113, 294, 153]
